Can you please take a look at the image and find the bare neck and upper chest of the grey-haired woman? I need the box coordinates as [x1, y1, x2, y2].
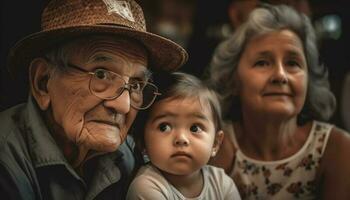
[234, 116, 309, 161]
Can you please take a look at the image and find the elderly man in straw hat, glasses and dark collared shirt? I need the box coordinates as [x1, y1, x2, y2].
[0, 0, 187, 200]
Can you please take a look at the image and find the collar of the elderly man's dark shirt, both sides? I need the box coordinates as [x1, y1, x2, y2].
[24, 95, 131, 188]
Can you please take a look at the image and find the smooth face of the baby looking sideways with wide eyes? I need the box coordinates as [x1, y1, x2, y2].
[144, 98, 217, 175]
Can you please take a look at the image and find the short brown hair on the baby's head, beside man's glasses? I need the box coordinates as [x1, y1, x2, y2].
[131, 71, 223, 148]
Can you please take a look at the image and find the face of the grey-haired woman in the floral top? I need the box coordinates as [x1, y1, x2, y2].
[236, 30, 308, 118]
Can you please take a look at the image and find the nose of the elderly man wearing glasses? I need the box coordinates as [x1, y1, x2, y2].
[104, 90, 130, 114]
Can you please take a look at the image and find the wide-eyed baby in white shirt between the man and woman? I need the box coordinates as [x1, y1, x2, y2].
[127, 72, 241, 200]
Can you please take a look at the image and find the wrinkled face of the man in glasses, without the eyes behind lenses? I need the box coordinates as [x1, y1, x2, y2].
[48, 38, 147, 152]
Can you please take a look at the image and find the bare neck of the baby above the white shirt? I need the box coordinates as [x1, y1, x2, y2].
[161, 169, 204, 198]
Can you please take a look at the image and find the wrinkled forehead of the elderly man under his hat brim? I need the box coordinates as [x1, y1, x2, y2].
[63, 36, 150, 77]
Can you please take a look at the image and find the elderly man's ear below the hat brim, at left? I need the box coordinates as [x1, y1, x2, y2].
[29, 58, 51, 110]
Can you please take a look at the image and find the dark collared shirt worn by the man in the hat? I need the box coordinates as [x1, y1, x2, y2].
[0, 97, 135, 200]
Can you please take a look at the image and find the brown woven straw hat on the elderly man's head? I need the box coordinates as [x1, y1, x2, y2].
[8, 0, 188, 75]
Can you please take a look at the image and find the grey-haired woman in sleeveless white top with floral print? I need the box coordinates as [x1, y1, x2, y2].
[209, 5, 350, 200]
